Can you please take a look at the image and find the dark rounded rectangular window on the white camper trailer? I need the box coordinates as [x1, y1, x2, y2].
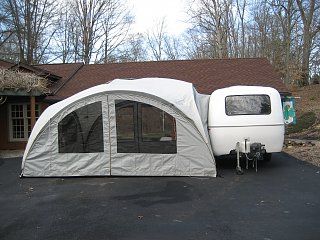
[226, 95, 271, 116]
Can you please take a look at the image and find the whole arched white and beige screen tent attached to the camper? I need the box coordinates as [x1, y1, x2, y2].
[21, 78, 216, 176]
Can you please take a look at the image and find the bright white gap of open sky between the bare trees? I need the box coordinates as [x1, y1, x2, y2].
[128, 0, 188, 35]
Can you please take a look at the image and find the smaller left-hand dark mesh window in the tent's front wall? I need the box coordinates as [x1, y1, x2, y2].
[58, 102, 103, 153]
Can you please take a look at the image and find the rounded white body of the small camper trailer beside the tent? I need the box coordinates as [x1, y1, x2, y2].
[208, 86, 284, 156]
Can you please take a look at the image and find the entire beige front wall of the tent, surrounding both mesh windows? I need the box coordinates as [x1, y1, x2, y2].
[22, 85, 216, 177]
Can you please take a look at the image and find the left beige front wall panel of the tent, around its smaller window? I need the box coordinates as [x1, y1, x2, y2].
[23, 94, 110, 176]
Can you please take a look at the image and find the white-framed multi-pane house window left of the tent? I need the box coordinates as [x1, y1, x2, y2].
[9, 103, 40, 141]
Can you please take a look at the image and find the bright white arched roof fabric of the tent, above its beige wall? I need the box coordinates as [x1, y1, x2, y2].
[24, 78, 208, 159]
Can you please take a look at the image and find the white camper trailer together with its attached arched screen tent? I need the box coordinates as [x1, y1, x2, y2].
[21, 78, 284, 177]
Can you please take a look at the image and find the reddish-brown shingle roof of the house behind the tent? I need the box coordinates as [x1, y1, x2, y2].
[45, 58, 287, 99]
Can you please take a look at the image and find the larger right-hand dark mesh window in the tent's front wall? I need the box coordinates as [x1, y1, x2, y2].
[116, 100, 177, 154]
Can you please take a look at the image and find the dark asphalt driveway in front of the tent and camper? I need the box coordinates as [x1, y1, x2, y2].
[0, 153, 320, 240]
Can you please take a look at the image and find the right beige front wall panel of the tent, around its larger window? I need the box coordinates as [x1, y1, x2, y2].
[108, 93, 216, 176]
